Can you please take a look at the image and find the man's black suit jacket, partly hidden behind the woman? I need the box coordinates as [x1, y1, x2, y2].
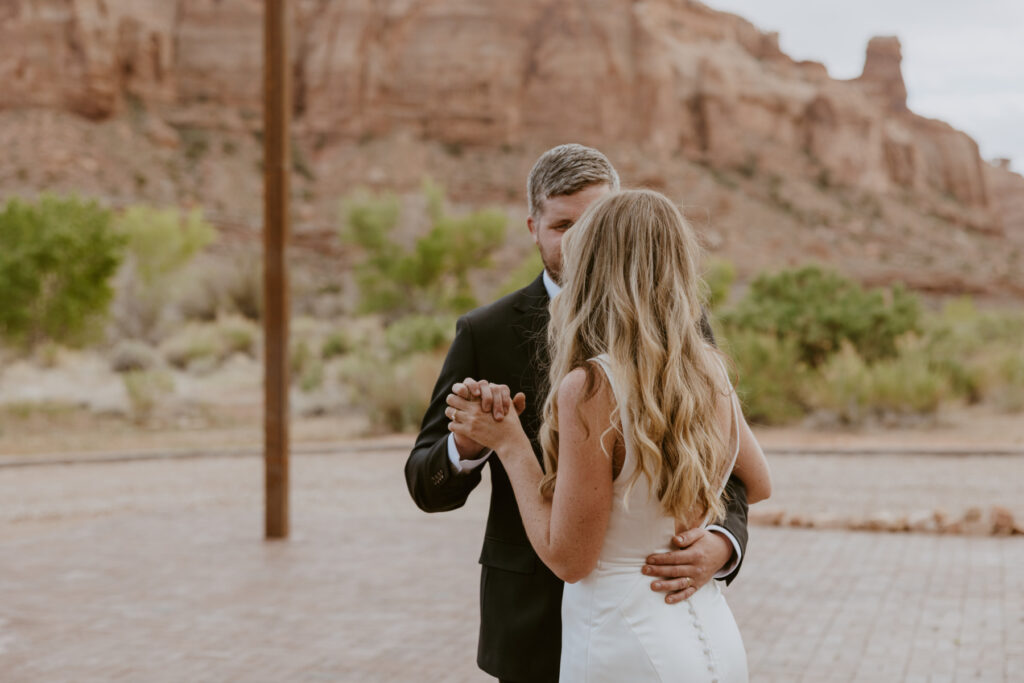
[406, 276, 746, 683]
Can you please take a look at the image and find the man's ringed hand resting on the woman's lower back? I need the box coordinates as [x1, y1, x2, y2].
[643, 528, 732, 603]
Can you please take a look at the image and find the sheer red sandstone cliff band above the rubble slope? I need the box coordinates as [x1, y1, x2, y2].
[0, 0, 998, 225]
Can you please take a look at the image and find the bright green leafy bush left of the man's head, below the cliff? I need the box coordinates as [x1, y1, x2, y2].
[340, 182, 506, 317]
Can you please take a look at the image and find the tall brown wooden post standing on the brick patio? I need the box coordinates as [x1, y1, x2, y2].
[263, 0, 292, 539]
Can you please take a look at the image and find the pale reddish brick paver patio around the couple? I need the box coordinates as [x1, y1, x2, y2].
[0, 453, 1024, 683]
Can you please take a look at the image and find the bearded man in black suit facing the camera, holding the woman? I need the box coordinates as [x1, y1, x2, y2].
[406, 144, 746, 683]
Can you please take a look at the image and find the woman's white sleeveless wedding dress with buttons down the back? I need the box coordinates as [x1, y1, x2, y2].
[559, 354, 748, 683]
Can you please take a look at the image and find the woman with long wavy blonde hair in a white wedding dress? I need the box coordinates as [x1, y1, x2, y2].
[447, 190, 771, 683]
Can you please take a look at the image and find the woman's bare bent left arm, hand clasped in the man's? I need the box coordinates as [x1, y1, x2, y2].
[449, 369, 615, 583]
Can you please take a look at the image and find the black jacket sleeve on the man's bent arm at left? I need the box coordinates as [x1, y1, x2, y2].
[406, 317, 481, 512]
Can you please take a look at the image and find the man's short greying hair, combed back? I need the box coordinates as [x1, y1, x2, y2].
[526, 143, 618, 218]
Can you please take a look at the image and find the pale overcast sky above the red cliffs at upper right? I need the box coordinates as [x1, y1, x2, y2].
[703, 0, 1024, 173]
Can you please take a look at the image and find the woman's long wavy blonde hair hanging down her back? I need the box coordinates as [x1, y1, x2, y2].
[541, 189, 729, 519]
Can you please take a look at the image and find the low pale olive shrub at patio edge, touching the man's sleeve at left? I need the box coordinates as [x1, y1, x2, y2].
[340, 351, 444, 432]
